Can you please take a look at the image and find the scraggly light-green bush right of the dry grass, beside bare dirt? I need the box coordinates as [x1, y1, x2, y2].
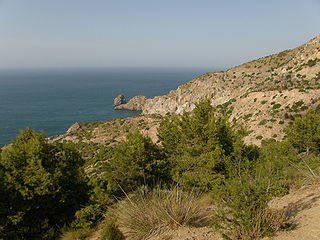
[213, 161, 287, 240]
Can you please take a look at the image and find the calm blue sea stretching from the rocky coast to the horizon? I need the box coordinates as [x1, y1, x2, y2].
[0, 69, 209, 146]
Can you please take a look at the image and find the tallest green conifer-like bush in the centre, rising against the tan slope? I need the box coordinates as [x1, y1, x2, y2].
[158, 100, 242, 191]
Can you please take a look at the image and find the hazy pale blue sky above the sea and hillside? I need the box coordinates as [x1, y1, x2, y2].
[0, 0, 320, 68]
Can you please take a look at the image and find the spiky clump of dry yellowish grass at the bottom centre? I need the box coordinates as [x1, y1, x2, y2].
[115, 187, 206, 240]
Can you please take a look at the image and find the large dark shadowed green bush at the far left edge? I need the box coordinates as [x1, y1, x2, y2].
[0, 129, 88, 239]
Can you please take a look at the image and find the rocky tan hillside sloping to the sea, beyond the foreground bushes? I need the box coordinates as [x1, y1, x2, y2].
[60, 36, 320, 145]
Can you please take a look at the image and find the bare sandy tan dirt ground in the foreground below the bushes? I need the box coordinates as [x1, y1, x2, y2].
[152, 183, 320, 240]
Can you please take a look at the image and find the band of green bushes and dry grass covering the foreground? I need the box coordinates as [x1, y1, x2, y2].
[0, 100, 320, 240]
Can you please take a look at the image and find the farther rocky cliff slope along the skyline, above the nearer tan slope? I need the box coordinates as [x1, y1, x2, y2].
[141, 36, 320, 115]
